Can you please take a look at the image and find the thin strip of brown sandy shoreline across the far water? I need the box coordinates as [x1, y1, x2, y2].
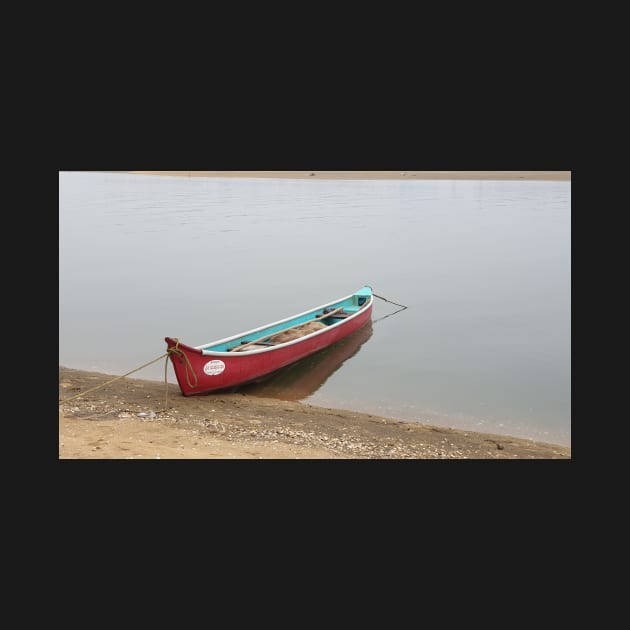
[119, 171, 571, 181]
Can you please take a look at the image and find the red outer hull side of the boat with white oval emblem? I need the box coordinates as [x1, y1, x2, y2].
[165, 296, 373, 396]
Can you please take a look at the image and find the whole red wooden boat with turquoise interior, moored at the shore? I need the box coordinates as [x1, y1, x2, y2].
[165, 286, 374, 396]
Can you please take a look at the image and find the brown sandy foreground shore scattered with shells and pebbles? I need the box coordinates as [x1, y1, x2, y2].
[59, 367, 571, 459]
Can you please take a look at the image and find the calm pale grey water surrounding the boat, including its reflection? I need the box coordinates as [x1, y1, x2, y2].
[59, 172, 571, 445]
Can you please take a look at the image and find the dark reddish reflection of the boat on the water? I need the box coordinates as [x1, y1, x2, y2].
[239, 321, 372, 400]
